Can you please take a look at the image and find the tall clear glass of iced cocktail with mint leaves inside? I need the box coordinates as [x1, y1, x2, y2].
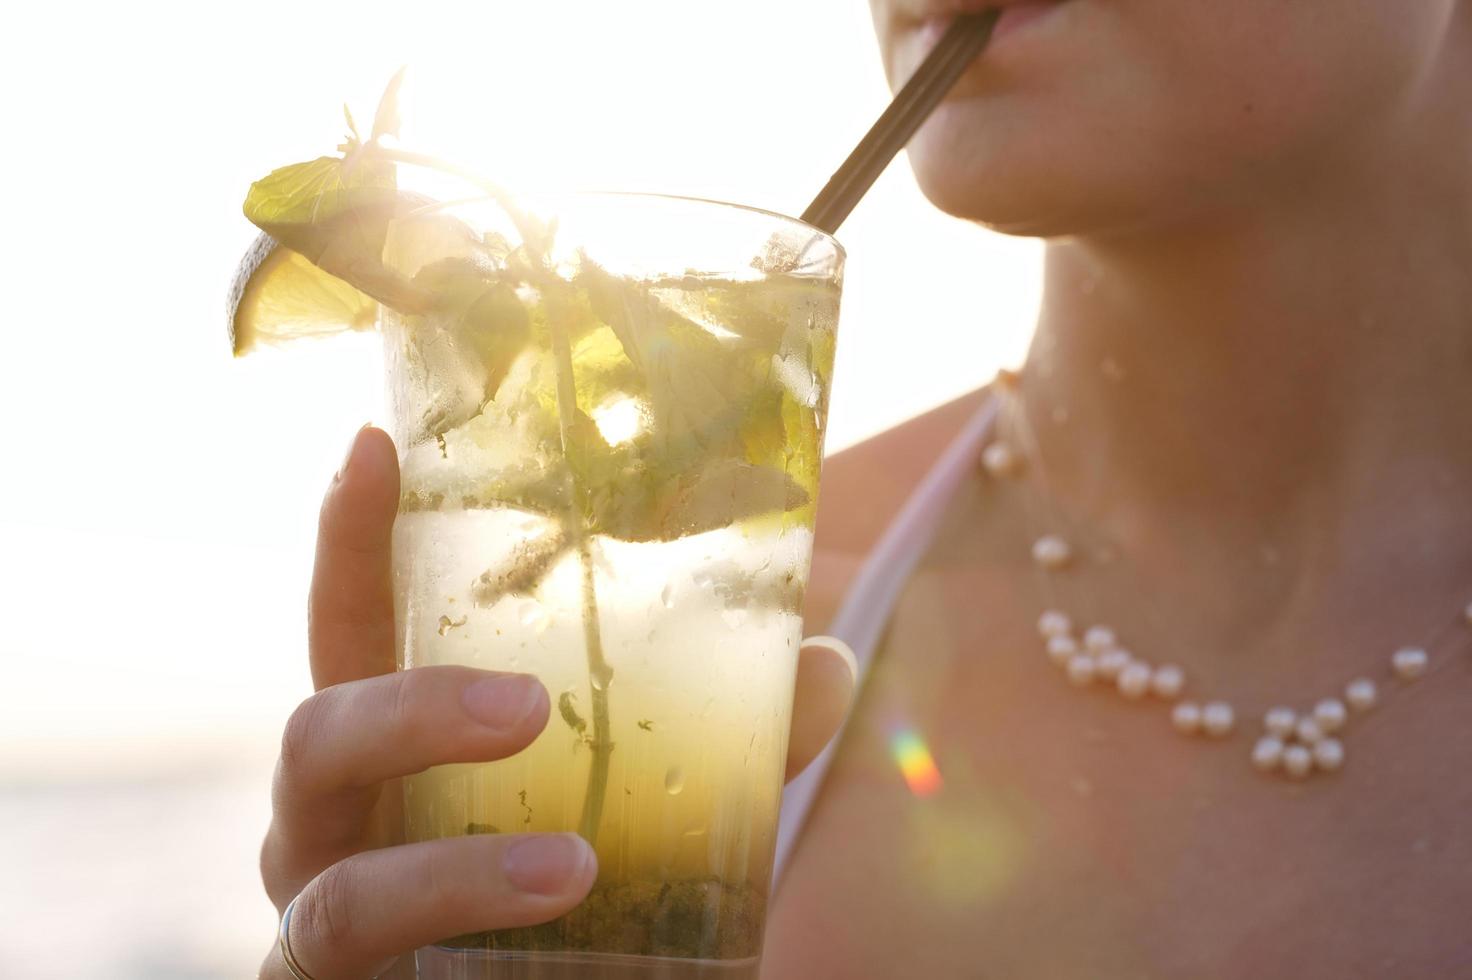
[383, 194, 843, 980]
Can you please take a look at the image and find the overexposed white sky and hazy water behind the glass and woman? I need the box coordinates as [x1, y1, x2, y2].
[0, 0, 1038, 980]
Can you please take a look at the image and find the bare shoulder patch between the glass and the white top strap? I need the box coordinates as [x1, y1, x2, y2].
[805, 388, 986, 633]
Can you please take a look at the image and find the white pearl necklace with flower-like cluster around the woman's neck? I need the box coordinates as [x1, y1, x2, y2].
[982, 369, 1472, 780]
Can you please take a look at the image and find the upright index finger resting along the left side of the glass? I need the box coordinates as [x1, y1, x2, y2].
[308, 425, 399, 690]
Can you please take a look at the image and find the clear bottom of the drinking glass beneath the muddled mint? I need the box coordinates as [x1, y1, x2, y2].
[414, 946, 761, 980]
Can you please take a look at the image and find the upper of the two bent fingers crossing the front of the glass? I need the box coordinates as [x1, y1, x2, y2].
[262, 665, 549, 887]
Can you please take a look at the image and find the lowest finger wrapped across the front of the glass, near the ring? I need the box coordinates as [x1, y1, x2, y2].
[277, 834, 598, 980]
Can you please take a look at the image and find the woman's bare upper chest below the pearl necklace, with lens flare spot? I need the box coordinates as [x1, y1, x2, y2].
[764, 574, 1472, 980]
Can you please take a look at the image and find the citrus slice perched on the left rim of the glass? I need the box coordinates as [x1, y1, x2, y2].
[228, 232, 378, 358]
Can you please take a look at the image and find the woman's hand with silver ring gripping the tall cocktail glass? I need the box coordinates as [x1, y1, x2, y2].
[261, 427, 854, 980]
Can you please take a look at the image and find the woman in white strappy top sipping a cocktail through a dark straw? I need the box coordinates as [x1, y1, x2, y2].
[263, 0, 1472, 980]
